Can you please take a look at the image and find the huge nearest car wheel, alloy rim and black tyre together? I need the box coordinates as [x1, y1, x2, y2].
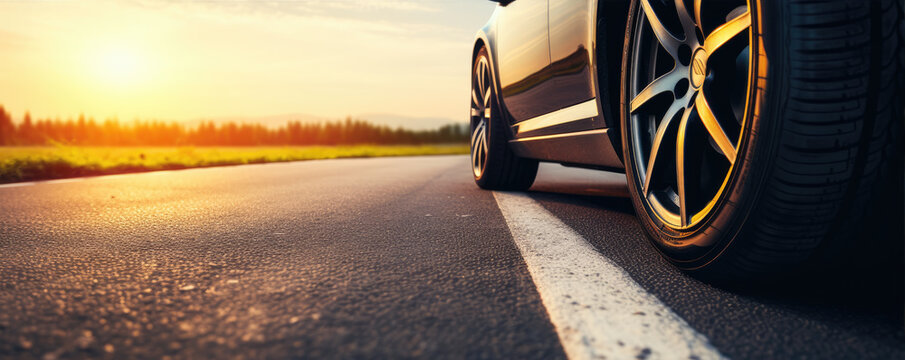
[621, 0, 903, 279]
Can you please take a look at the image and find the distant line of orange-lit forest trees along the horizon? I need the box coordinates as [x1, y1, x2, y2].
[0, 106, 469, 146]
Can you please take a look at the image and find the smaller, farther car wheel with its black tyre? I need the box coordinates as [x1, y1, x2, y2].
[471, 48, 537, 190]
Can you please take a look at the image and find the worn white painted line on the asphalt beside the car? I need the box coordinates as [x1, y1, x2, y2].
[493, 192, 723, 360]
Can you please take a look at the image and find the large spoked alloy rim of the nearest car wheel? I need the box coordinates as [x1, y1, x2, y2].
[626, 0, 753, 230]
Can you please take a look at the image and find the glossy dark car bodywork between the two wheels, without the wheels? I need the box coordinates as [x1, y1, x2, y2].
[474, 0, 628, 170]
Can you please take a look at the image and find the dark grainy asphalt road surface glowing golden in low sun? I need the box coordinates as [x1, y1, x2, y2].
[0, 156, 905, 359]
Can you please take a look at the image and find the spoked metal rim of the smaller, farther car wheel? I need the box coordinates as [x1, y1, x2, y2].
[471, 56, 492, 178]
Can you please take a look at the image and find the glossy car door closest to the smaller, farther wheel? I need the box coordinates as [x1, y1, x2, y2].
[496, 0, 555, 123]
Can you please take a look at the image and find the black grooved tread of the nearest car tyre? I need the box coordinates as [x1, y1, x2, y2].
[729, 0, 905, 277]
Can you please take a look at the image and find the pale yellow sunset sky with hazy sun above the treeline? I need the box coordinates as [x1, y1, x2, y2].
[0, 0, 494, 125]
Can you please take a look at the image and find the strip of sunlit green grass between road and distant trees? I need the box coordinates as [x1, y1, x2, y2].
[0, 145, 468, 183]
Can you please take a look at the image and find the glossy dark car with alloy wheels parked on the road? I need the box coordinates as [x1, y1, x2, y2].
[469, 0, 905, 281]
